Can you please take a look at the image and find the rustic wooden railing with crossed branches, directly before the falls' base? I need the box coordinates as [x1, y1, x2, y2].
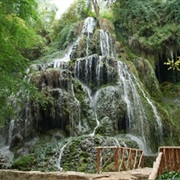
[96, 146, 144, 173]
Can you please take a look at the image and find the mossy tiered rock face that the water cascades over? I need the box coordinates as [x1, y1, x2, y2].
[3, 18, 172, 172]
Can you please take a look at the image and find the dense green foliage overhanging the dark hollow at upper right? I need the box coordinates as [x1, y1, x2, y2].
[113, 0, 180, 52]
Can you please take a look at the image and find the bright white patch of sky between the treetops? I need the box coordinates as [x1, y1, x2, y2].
[52, 0, 74, 19]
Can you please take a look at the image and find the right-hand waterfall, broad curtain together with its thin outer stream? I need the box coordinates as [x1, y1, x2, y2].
[118, 62, 163, 152]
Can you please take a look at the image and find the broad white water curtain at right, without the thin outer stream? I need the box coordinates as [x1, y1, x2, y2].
[118, 61, 149, 153]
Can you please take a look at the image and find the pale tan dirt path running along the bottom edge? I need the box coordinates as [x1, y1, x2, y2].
[0, 168, 152, 180]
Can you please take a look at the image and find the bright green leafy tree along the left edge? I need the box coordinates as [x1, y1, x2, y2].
[0, 0, 44, 123]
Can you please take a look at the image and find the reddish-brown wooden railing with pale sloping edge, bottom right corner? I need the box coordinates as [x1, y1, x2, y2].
[149, 146, 180, 180]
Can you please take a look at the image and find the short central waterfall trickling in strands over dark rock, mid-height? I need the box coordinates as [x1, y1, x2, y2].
[74, 54, 115, 89]
